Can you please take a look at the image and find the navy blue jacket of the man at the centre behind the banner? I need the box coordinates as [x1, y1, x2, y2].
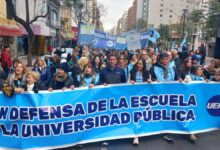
[99, 67, 127, 84]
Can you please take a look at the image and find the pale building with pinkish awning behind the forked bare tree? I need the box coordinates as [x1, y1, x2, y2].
[13, 0, 50, 55]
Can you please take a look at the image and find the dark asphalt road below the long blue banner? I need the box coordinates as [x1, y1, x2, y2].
[57, 131, 220, 150]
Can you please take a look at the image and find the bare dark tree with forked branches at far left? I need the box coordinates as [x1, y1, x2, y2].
[6, 0, 47, 66]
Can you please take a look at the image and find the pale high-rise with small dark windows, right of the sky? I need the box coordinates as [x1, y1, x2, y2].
[136, 0, 189, 28]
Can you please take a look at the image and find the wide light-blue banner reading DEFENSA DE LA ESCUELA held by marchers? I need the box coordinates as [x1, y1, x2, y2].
[0, 83, 220, 149]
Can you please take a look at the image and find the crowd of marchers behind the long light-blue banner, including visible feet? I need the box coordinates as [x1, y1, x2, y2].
[0, 46, 220, 144]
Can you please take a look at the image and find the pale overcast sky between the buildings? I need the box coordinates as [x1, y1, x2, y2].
[98, 0, 133, 31]
